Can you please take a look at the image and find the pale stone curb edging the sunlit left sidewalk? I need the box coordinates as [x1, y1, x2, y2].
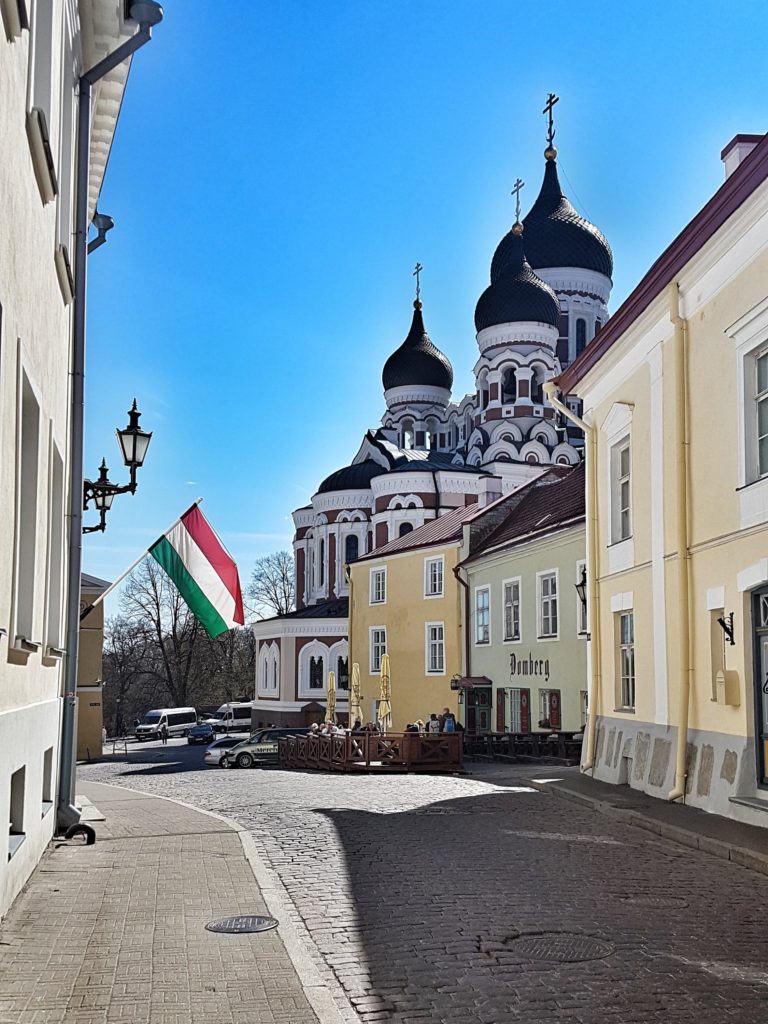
[79, 782, 361, 1024]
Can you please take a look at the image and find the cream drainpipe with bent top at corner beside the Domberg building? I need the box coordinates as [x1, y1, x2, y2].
[544, 381, 601, 775]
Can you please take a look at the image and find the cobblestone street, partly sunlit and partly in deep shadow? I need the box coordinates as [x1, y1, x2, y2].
[80, 743, 768, 1024]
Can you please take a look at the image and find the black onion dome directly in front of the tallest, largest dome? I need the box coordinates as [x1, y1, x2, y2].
[475, 231, 560, 333]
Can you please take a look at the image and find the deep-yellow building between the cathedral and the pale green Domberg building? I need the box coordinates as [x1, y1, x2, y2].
[349, 506, 478, 732]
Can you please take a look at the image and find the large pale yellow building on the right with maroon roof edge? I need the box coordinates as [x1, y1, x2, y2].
[548, 136, 768, 824]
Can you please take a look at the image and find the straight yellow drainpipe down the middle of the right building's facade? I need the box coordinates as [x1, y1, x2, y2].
[667, 282, 693, 801]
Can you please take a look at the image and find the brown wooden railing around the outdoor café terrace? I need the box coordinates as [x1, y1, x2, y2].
[278, 732, 463, 772]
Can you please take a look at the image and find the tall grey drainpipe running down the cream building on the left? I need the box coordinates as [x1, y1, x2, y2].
[56, 0, 163, 829]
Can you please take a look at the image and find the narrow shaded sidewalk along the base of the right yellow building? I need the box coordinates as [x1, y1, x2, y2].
[530, 770, 768, 874]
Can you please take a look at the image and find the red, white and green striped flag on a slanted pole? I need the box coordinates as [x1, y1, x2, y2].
[150, 505, 246, 637]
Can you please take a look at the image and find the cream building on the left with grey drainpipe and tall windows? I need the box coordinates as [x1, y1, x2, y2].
[0, 0, 151, 914]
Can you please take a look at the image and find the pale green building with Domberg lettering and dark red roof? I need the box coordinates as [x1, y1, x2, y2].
[459, 464, 588, 732]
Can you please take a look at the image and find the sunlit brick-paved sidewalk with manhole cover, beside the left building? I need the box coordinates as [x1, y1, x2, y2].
[0, 783, 327, 1024]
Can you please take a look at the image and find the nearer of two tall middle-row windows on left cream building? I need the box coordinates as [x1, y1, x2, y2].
[14, 373, 40, 649]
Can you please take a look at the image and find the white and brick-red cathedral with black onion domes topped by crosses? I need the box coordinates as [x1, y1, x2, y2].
[254, 96, 613, 725]
